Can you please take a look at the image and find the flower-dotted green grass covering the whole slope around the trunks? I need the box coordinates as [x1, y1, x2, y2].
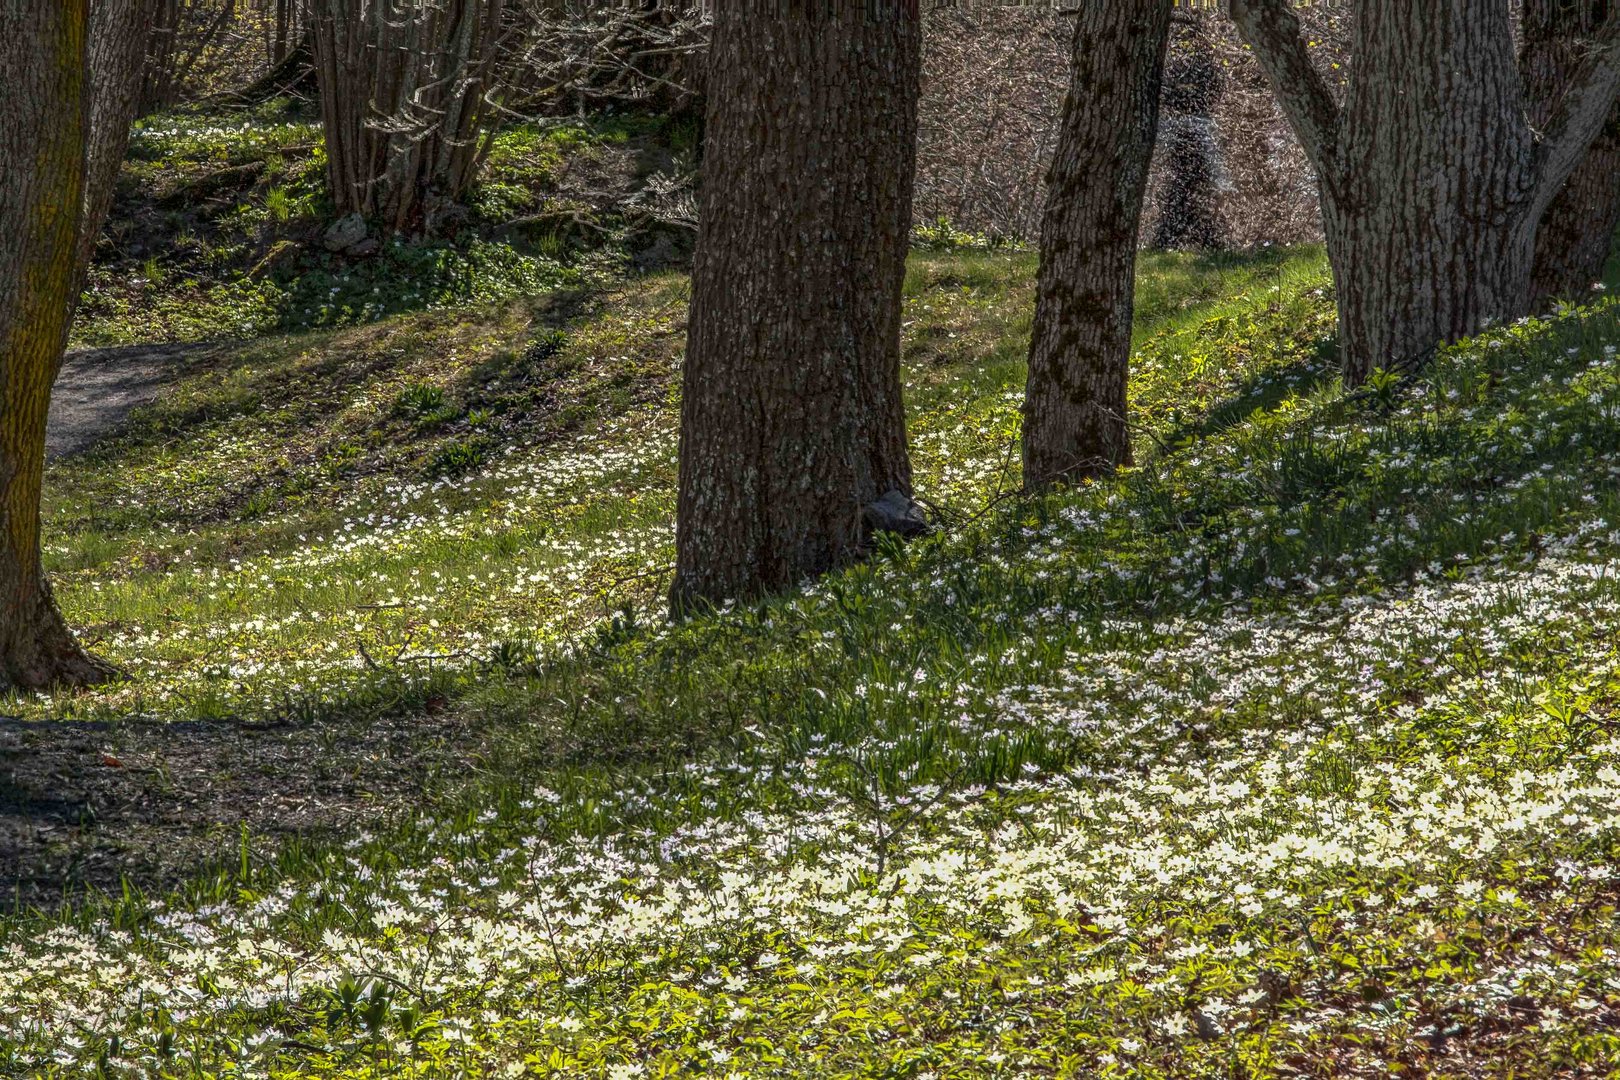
[12, 249, 1620, 1078]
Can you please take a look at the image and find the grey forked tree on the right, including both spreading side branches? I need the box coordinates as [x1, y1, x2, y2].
[1231, 0, 1620, 385]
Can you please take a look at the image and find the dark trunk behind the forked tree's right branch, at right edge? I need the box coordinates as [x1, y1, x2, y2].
[1520, 0, 1620, 309]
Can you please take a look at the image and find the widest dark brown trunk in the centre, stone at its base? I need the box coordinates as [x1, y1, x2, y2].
[671, 0, 920, 612]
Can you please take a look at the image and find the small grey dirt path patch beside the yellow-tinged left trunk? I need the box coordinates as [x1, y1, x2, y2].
[45, 345, 206, 458]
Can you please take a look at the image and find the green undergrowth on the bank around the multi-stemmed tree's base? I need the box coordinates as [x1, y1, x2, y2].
[75, 99, 690, 347]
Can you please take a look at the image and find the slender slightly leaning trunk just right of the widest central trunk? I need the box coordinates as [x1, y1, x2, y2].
[1024, 0, 1173, 491]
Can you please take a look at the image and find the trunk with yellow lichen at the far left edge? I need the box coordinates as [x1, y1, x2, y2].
[0, 0, 109, 690]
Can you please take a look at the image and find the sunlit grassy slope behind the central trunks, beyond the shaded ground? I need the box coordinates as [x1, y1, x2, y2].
[41, 253, 1325, 719]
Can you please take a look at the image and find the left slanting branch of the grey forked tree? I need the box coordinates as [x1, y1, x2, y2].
[1230, 0, 1338, 191]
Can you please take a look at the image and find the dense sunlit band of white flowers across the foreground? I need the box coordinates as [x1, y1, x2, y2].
[0, 521, 1620, 1065]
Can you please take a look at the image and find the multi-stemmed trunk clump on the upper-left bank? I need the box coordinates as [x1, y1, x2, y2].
[309, 0, 505, 233]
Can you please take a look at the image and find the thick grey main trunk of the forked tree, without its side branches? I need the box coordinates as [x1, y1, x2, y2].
[1324, 0, 1536, 385]
